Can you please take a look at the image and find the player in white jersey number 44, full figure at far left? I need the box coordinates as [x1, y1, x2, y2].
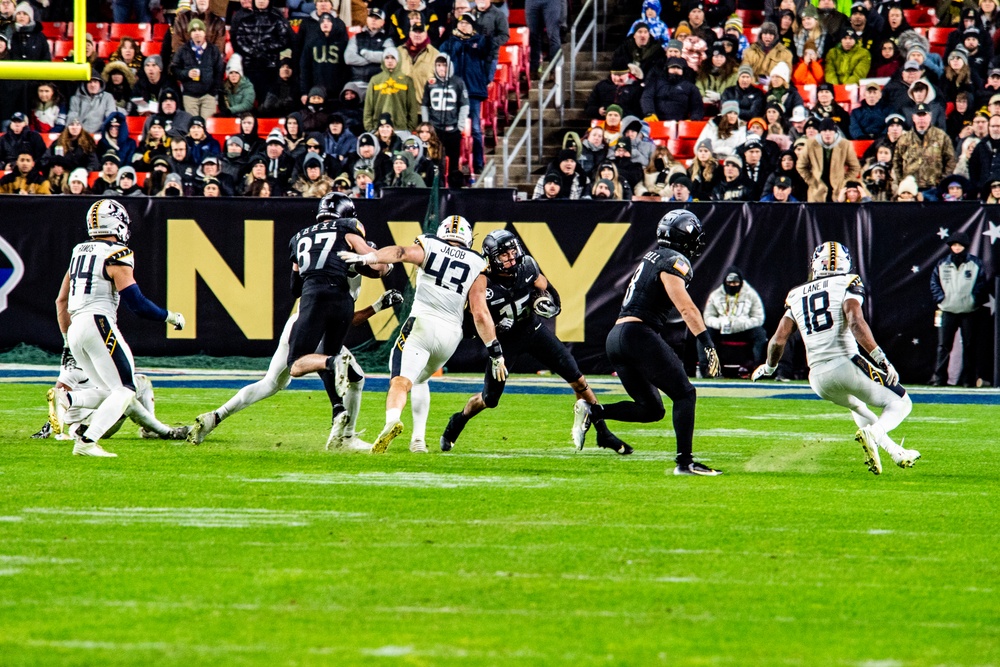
[56, 199, 184, 457]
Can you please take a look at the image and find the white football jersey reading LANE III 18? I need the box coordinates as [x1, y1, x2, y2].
[785, 273, 865, 368]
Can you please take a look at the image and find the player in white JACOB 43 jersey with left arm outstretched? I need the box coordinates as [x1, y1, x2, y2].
[340, 215, 507, 454]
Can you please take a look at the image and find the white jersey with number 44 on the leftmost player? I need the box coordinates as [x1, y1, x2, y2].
[69, 241, 135, 322]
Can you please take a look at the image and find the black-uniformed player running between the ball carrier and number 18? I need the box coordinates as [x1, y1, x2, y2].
[591, 209, 722, 475]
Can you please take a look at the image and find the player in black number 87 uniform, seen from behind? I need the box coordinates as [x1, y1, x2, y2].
[288, 192, 389, 416]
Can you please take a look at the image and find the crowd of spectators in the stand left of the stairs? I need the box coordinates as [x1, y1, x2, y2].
[0, 0, 516, 197]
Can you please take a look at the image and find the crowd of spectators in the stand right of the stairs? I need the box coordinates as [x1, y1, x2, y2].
[533, 0, 1000, 203]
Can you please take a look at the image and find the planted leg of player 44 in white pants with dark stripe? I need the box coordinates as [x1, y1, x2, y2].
[69, 315, 135, 456]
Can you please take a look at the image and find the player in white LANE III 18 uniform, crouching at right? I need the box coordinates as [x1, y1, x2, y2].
[751, 241, 920, 475]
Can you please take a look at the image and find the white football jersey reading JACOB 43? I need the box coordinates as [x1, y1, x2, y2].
[410, 234, 486, 328]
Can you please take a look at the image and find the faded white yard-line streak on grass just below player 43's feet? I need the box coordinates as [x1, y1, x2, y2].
[233, 472, 564, 489]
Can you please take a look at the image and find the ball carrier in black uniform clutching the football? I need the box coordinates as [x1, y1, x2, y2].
[441, 229, 632, 454]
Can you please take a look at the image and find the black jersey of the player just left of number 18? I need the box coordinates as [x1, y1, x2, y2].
[619, 248, 694, 331]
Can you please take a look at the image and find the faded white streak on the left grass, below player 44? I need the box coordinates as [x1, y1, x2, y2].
[22, 507, 368, 528]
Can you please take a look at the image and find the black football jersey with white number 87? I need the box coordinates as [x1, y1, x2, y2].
[288, 218, 365, 289]
